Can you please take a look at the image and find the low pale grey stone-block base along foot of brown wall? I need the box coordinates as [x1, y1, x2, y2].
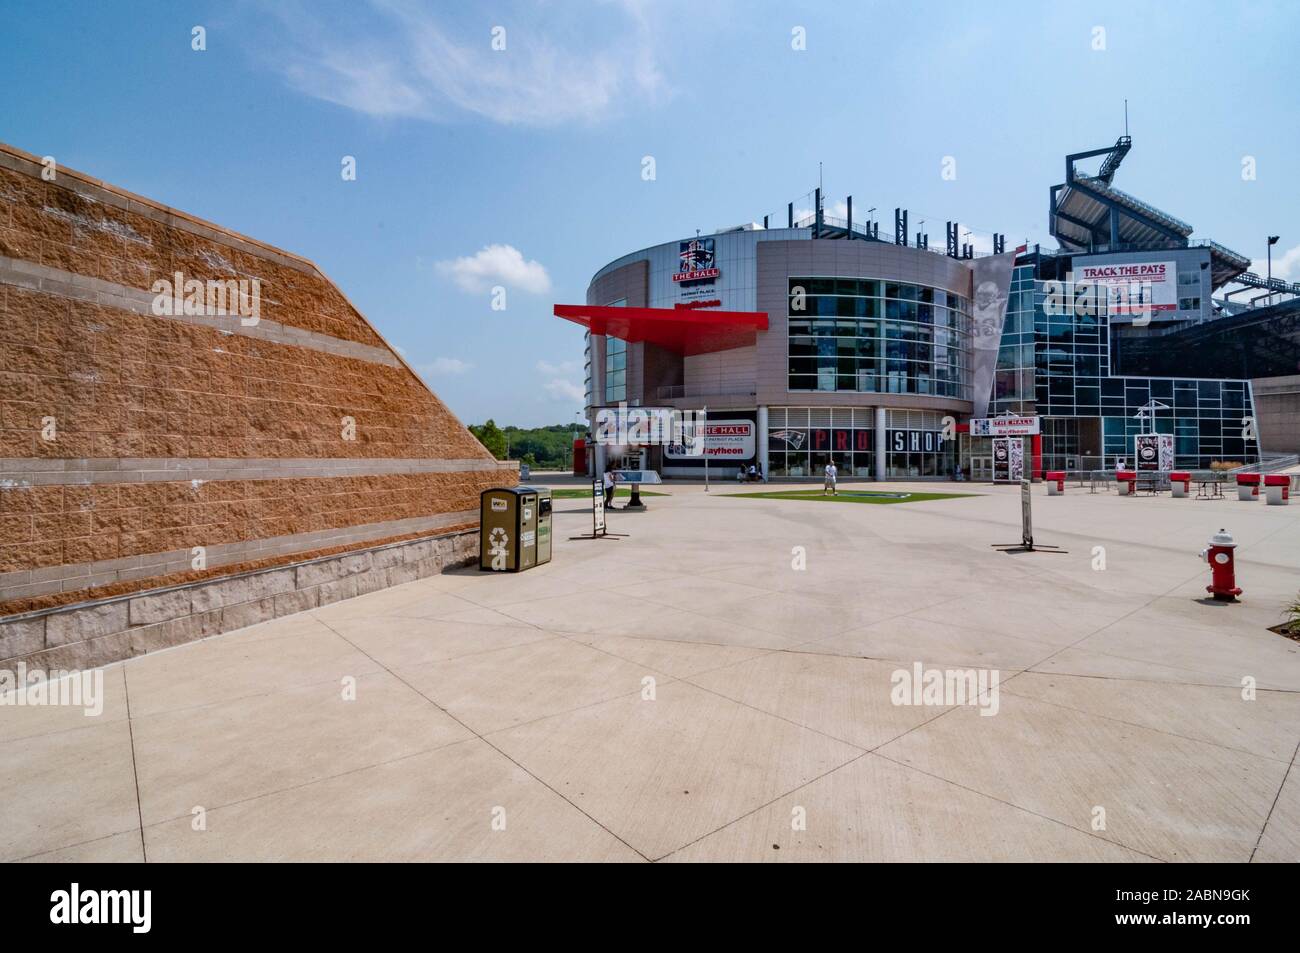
[0, 530, 478, 671]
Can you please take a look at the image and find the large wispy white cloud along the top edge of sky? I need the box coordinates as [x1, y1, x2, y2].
[257, 0, 664, 126]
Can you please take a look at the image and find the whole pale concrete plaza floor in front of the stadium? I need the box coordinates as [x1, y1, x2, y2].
[0, 484, 1300, 862]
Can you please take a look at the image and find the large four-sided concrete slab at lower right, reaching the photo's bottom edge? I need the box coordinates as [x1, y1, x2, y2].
[880, 692, 1286, 862]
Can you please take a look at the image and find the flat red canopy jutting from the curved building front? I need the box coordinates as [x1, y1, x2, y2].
[555, 304, 767, 355]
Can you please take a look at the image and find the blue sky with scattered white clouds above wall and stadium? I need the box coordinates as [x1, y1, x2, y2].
[0, 0, 1300, 425]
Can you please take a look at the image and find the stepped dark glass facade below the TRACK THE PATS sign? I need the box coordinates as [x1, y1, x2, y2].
[972, 265, 1258, 469]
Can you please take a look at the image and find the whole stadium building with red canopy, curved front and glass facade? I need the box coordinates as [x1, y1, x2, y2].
[555, 137, 1300, 480]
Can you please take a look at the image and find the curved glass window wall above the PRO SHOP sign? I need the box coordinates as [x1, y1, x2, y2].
[787, 277, 971, 399]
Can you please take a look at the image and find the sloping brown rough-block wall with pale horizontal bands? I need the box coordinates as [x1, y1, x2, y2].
[0, 144, 517, 631]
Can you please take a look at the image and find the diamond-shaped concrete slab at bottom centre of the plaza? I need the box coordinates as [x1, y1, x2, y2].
[491, 681, 861, 859]
